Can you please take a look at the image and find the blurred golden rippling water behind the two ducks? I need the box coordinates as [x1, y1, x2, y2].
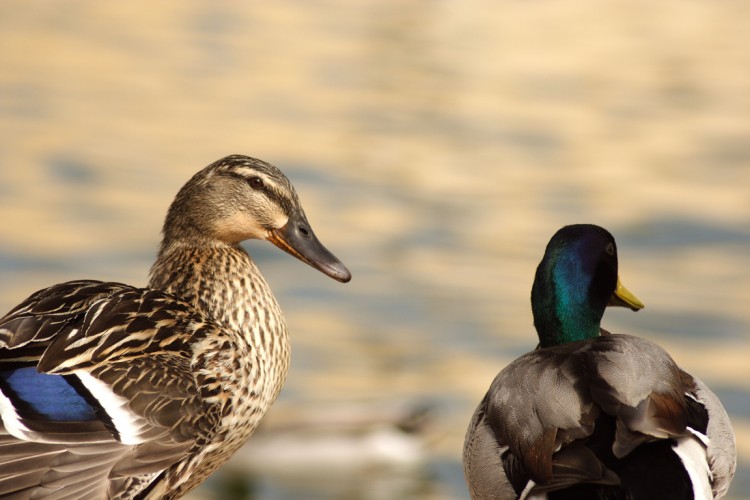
[0, 0, 750, 500]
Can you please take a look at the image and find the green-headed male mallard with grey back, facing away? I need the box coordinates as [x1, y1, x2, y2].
[464, 225, 735, 500]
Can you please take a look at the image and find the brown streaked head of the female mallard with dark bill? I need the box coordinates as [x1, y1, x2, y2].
[162, 155, 351, 283]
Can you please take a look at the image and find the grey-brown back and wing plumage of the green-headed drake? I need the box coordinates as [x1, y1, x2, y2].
[464, 334, 734, 498]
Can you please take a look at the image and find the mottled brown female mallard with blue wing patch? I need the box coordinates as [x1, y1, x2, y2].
[0, 155, 351, 499]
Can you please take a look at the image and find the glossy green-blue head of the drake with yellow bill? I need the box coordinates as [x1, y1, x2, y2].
[531, 224, 644, 347]
